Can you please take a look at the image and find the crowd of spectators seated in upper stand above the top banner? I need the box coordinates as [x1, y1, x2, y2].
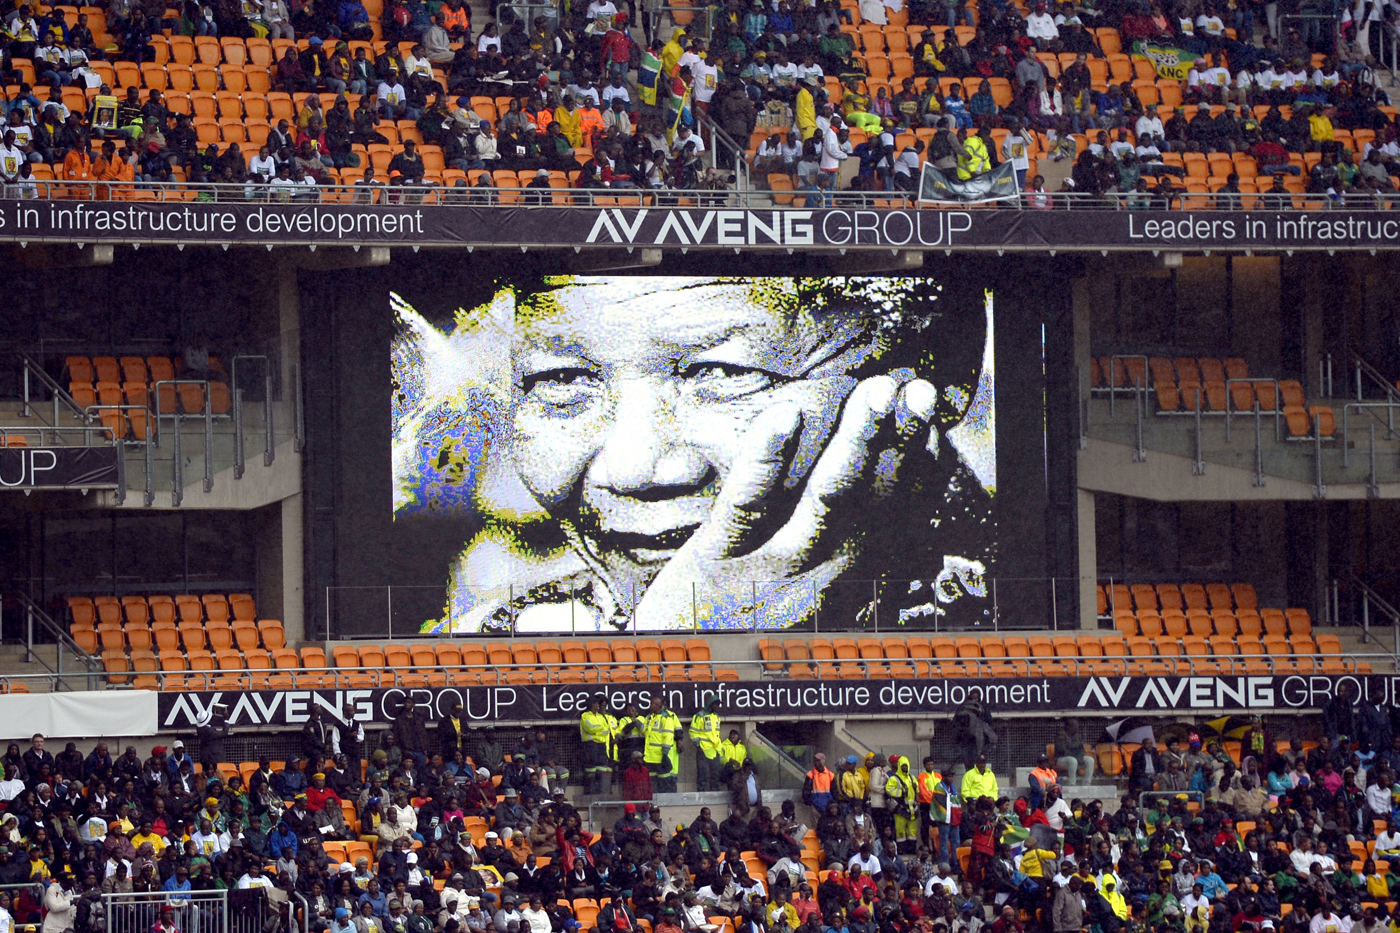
[0, 0, 1400, 206]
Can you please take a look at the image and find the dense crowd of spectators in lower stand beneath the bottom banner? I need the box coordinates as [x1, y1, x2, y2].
[0, 683, 1400, 933]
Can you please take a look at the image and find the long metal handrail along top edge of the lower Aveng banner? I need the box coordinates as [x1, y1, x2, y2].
[76, 651, 1400, 689]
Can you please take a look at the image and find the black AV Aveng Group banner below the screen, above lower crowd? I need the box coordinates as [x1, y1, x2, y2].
[158, 675, 1400, 731]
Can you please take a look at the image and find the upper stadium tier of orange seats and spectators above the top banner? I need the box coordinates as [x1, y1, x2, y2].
[4, 0, 1400, 210]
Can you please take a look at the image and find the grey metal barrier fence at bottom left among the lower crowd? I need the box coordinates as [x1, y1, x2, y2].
[102, 888, 286, 933]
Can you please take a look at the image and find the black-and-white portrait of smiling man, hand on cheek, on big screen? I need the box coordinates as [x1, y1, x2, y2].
[391, 275, 997, 635]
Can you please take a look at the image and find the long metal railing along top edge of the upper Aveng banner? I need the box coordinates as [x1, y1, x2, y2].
[5, 174, 1400, 208]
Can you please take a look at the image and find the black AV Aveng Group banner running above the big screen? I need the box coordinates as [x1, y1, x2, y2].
[8, 200, 1400, 252]
